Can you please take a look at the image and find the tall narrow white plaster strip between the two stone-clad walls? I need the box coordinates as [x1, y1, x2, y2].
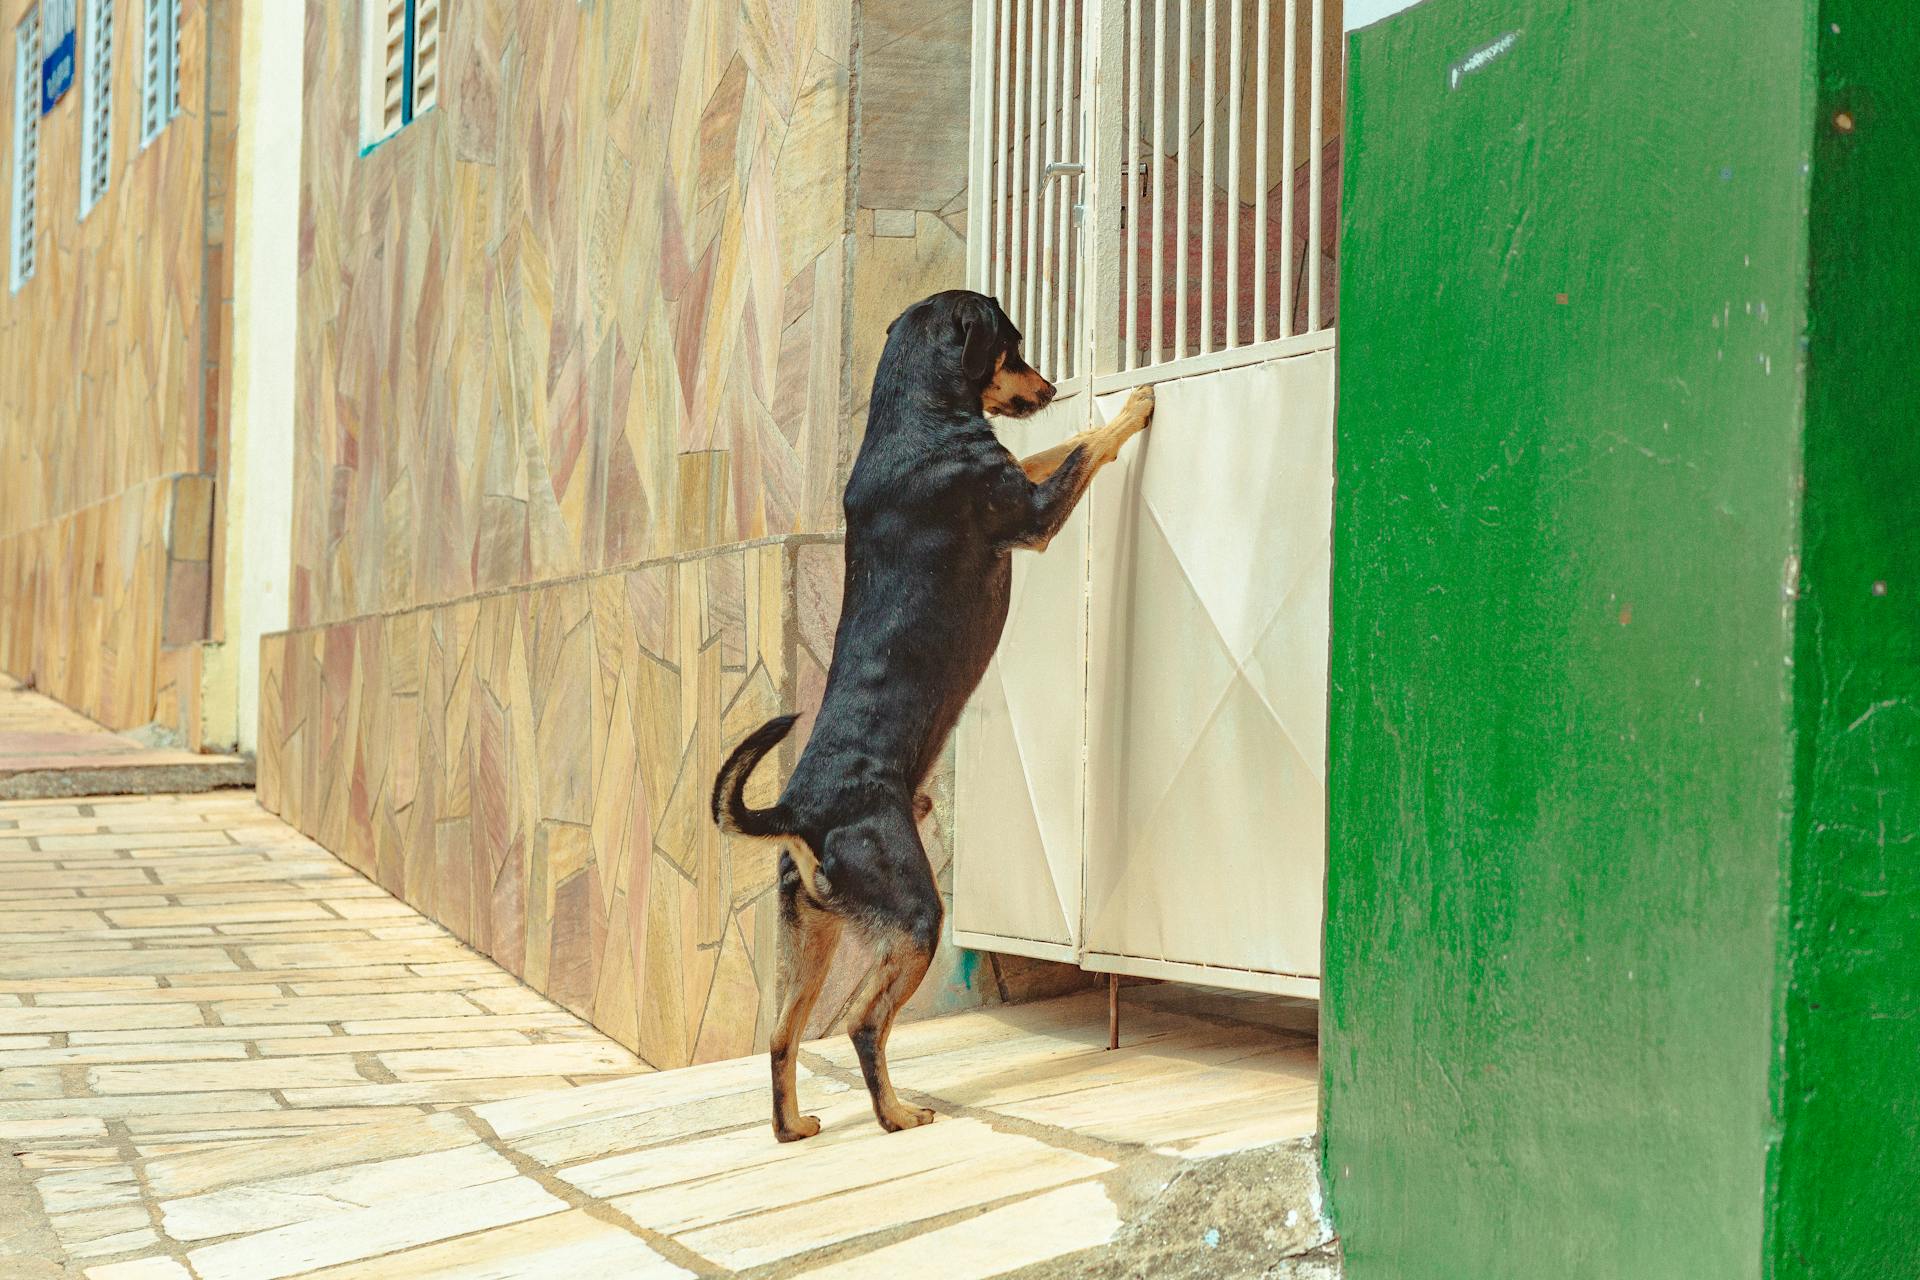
[221, 0, 305, 750]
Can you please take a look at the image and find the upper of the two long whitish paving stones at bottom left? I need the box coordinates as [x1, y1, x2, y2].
[159, 1142, 515, 1244]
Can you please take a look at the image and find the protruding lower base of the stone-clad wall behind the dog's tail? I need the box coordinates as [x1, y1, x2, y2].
[259, 539, 1066, 1067]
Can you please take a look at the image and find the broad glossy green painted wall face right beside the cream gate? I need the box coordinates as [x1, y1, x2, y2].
[1323, 0, 1820, 1280]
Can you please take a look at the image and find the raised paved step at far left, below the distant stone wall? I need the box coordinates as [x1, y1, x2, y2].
[0, 672, 253, 800]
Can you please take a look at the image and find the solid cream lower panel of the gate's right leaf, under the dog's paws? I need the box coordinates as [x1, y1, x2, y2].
[1081, 351, 1332, 994]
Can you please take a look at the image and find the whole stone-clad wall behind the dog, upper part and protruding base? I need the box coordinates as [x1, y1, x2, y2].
[259, 0, 1079, 1067]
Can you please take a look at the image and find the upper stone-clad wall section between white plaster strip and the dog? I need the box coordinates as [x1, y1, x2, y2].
[294, 0, 851, 628]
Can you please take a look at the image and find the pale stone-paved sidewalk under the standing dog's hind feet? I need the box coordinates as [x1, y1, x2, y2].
[0, 793, 1336, 1280]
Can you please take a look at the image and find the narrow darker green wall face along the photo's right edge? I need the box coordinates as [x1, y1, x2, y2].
[1770, 0, 1920, 1280]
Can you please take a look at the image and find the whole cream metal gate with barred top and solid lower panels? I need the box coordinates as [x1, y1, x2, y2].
[954, 0, 1340, 992]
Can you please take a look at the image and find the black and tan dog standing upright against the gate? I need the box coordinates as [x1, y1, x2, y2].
[712, 290, 1154, 1142]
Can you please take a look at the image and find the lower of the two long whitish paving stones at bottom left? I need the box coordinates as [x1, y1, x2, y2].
[188, 1178, 566, 1280]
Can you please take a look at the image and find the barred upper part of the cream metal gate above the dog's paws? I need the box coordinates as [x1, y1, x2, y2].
[970, 0, 1340, 390]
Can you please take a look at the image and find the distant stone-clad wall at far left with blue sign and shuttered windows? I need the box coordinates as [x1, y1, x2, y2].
[0, 0, 236, 737]
